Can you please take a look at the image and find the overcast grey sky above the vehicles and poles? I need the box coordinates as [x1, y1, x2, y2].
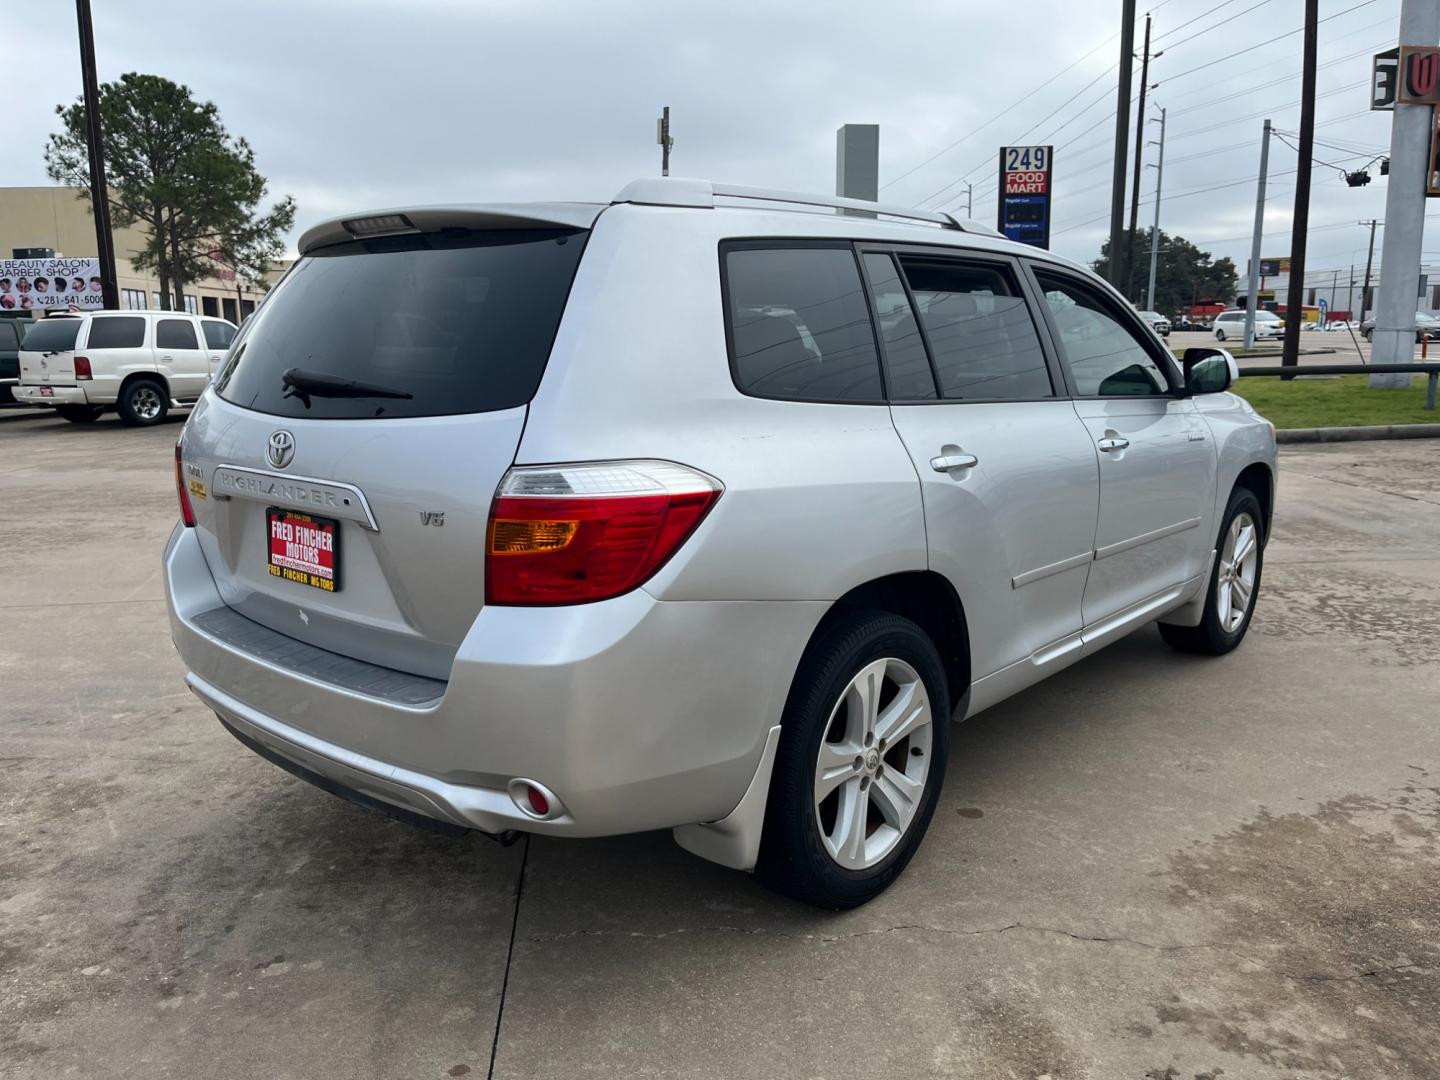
[0, 0, 1416, 296]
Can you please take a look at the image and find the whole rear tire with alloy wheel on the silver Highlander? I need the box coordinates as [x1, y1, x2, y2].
[756, 611, 950, 910]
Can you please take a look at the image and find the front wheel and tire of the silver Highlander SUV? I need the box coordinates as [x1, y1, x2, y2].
[1161, 488, 1264, 657]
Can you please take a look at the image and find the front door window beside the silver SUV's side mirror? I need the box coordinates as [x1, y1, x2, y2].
[1035, 271, 1168, 397]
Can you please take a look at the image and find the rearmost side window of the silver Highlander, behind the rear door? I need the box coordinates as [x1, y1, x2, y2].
[724, 245, 883, 402]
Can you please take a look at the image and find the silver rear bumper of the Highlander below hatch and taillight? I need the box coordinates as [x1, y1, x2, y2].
[164, 527, 827, 837]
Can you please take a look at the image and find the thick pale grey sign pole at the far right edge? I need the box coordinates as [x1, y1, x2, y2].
[1369, 0, 1440, 387]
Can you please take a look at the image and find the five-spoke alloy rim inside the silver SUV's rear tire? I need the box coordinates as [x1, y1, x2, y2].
[814, 657, 935, 870]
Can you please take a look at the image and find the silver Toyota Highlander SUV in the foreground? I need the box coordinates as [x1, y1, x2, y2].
[164, 180, 1276, 907]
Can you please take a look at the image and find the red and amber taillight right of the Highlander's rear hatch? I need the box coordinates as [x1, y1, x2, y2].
[485, 461, 721, 605]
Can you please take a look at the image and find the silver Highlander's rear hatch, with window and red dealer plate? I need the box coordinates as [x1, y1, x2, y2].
[183, 213, 593, 678]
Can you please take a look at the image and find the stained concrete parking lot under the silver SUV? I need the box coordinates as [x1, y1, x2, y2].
[0, 408, 1440, 1080]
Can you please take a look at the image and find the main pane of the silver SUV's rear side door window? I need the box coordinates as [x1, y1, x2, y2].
[900, 255, 1053, 400]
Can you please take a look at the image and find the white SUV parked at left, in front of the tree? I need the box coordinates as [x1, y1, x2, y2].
[14, 311, 236, 426]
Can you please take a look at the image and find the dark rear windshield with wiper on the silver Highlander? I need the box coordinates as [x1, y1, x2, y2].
[216, 230, 586, 419]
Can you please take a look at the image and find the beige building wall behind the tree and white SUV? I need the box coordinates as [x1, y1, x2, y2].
[0, 187, 288, 323]
